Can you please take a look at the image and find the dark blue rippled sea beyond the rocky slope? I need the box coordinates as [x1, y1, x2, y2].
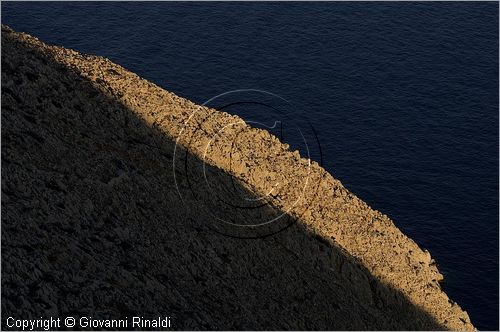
[2, 2, 499, 330]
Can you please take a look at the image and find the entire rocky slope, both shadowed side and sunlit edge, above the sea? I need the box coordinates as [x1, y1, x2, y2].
[2, 27, 473, 330]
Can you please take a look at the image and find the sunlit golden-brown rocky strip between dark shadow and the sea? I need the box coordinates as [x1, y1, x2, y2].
[2, 28, 473, 330]
